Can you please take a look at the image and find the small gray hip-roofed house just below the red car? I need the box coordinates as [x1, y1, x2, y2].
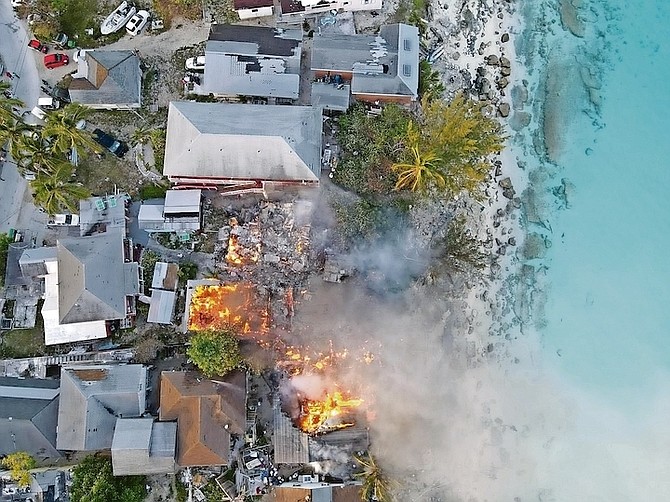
[68, 49, 142, 110]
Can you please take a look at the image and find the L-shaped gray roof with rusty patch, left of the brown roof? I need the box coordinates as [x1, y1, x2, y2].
[56, 364, 147, 451]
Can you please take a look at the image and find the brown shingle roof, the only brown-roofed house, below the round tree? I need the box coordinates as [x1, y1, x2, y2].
[159, 371, 246, 467]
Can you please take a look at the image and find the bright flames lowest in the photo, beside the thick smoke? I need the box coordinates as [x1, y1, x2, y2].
[299, 391, 363, 434]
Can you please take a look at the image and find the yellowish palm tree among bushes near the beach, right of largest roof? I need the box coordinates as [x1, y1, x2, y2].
[391, 122, 445, 192]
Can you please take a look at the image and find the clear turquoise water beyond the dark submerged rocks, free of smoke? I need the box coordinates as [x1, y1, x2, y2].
[542, 0, 670, 404]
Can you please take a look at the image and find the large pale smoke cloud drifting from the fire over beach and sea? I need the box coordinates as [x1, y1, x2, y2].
[295, 190, 670, 502]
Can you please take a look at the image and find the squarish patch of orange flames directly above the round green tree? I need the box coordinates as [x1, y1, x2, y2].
[188, 283, 267, 333]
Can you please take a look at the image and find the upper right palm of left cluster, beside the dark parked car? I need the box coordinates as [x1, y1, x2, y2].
[42, 103, 98, 154]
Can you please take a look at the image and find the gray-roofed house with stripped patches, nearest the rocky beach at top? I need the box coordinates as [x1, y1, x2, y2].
[311, 23, 419, 104]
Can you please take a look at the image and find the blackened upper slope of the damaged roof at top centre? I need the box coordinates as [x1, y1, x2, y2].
[208, 24, 302, 56]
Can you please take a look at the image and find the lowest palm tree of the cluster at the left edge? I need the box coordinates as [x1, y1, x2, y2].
[30, 160, 91, 214]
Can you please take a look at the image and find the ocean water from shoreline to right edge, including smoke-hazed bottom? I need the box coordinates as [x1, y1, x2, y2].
[517, 0, 670, 501]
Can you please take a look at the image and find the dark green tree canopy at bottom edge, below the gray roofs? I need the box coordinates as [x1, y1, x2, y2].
[70, 455, 146, 502]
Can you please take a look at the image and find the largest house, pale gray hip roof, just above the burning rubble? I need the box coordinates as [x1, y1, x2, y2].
[163, 101, 322, 193]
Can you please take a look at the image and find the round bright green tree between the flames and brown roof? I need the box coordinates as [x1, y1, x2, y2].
[186, 330, 243, 377]
